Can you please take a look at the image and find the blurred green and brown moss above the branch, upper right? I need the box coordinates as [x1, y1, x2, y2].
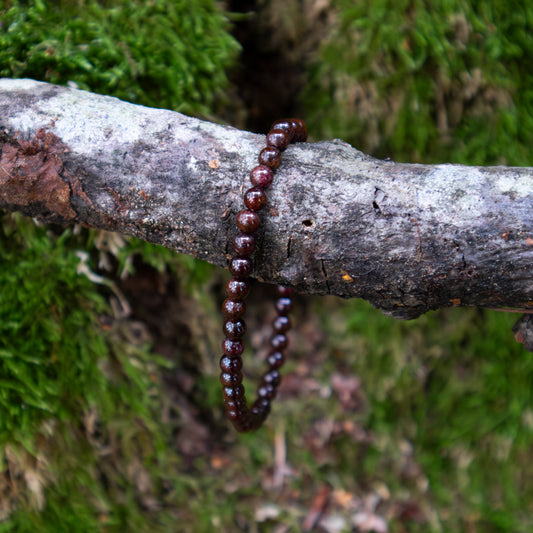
[305, 0, 533, 165]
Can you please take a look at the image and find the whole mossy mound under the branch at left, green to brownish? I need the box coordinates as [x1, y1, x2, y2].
[0, 215, 183, 532]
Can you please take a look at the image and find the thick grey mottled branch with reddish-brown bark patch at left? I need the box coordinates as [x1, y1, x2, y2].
[0, 79, 533, 318]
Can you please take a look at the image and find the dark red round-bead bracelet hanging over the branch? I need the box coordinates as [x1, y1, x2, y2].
[220, 118, 307, 432]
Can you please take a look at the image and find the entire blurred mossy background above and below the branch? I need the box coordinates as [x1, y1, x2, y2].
[0, 0, 533, 533]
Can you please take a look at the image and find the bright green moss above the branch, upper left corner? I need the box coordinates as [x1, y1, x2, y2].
[0, 0, 238, 114]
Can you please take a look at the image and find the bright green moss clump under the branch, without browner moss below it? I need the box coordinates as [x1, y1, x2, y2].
[0, 217, 107, 442]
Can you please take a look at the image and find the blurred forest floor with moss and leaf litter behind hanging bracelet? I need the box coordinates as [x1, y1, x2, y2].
[116, 255, 533, 533]
